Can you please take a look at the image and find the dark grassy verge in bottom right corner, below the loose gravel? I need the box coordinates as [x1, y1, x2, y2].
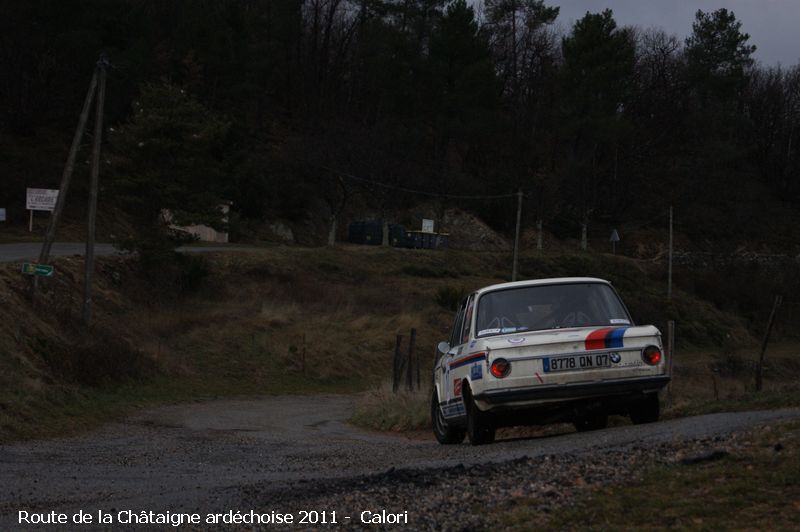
[520, 421, 800, 530]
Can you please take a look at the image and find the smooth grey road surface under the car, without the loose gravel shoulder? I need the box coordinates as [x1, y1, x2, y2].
[0, 396, 800, 530]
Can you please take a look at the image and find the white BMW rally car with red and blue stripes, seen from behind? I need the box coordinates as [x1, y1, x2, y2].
[431, 277, 670, 445]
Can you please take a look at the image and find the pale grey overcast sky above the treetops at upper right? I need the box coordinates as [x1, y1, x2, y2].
[512, 0, 800, 66]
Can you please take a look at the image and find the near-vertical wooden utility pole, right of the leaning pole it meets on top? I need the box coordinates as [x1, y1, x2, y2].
[82, 54, 108, 328]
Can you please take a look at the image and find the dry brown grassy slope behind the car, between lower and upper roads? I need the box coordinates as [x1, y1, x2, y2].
[0, 246, 764, 440]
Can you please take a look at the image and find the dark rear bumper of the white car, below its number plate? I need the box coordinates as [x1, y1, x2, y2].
[475, 375, 670, 406]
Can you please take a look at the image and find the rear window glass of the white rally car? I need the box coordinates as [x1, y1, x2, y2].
[475, 283, 631, 337]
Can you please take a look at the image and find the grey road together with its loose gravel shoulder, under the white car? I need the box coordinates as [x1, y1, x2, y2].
[0, 396, 800, 530]
